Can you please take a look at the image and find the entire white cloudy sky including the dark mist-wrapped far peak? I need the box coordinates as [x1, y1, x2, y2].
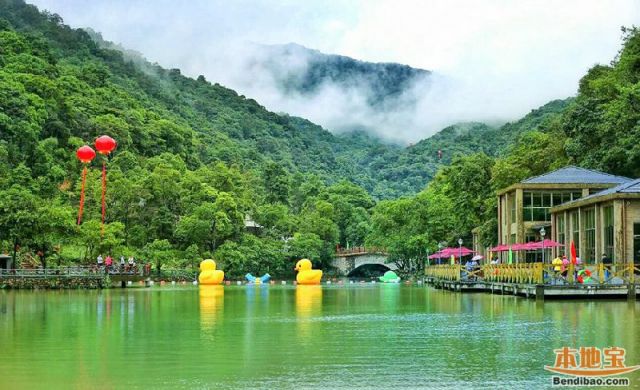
[32, 0, 640, 143]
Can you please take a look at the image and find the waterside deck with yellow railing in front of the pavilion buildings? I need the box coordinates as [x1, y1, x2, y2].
[425, 263, 640, 299]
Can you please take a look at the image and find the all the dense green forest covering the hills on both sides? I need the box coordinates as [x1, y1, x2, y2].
[0, 0, 640, 277]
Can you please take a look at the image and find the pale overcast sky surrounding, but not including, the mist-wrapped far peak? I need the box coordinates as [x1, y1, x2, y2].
[30, 0, 640, 140]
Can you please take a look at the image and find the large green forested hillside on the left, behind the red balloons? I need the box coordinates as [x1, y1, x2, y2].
[0, 0, 380, 275]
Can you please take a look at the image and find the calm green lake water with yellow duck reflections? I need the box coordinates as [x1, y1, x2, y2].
[0, 284, 640, 389]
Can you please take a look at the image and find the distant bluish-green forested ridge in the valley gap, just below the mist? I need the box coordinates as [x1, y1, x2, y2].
[324, 99, 572, 199]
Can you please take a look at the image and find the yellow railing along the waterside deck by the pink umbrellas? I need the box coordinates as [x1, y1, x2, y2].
[425, 263, 640, 284]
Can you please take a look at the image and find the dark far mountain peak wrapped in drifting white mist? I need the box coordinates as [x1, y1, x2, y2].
[215, 43, 519, 143]
